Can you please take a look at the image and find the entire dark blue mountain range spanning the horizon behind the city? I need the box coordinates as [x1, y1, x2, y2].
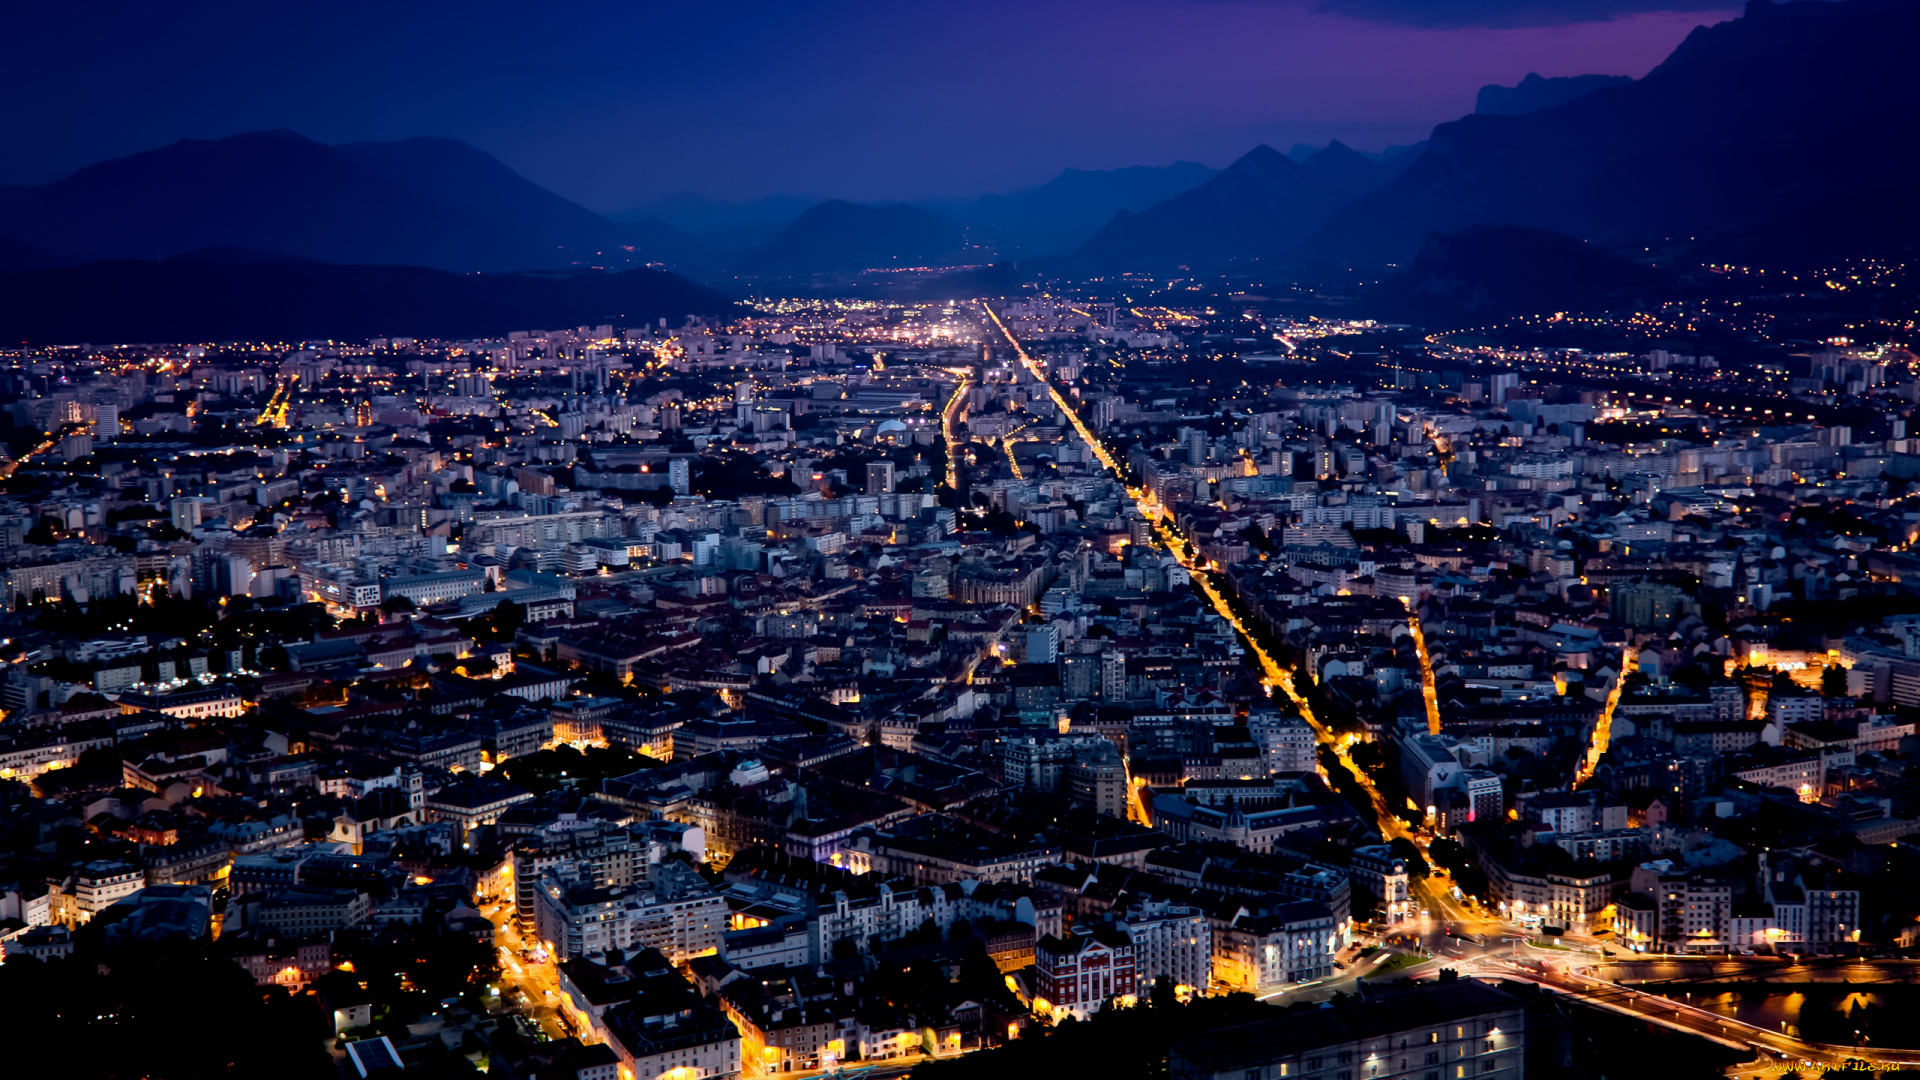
[0, 0, 1920, 336]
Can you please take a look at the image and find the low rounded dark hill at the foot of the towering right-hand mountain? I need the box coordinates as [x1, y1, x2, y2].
[1377, 225, 1663, 325]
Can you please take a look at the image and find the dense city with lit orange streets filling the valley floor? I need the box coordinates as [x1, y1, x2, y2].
[0, 270, 1920, 1080]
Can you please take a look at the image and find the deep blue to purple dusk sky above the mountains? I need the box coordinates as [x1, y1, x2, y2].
[0, 0, 1736, 211]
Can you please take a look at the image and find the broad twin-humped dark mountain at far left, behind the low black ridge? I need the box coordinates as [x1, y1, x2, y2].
[0, 131, 684, 271]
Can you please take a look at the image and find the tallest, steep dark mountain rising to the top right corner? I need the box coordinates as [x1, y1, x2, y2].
[1304, 0, 1920, 263]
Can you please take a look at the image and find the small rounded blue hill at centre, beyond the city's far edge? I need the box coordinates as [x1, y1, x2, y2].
[739, 200, 966, 277]
